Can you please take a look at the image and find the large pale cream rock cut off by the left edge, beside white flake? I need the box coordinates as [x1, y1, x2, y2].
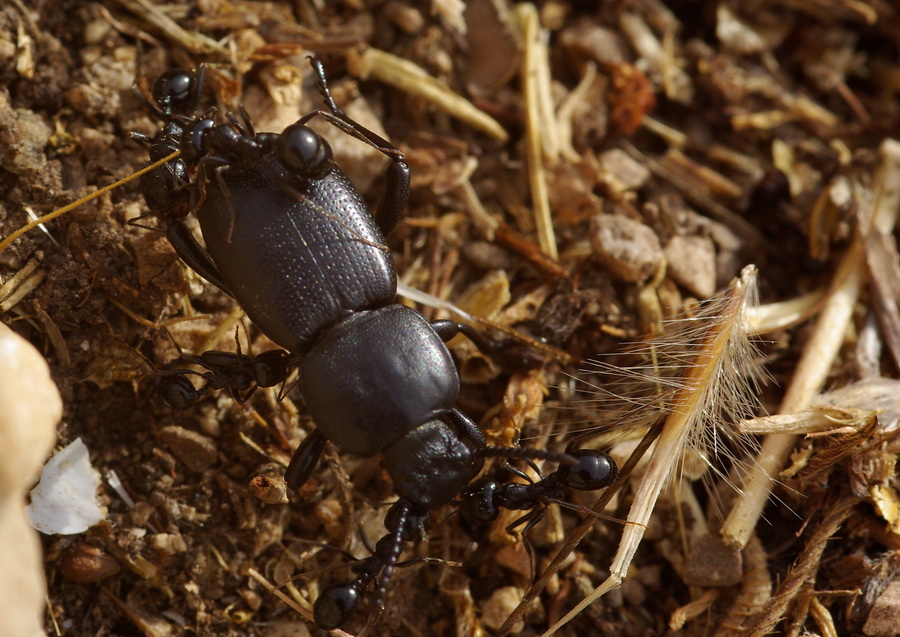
[0, 325, 62, 637]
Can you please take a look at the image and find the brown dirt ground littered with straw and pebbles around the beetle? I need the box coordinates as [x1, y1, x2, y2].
[0, 0, 900, 637]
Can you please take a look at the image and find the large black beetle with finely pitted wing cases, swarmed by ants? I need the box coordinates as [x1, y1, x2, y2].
[144, 59, 614, 629]
